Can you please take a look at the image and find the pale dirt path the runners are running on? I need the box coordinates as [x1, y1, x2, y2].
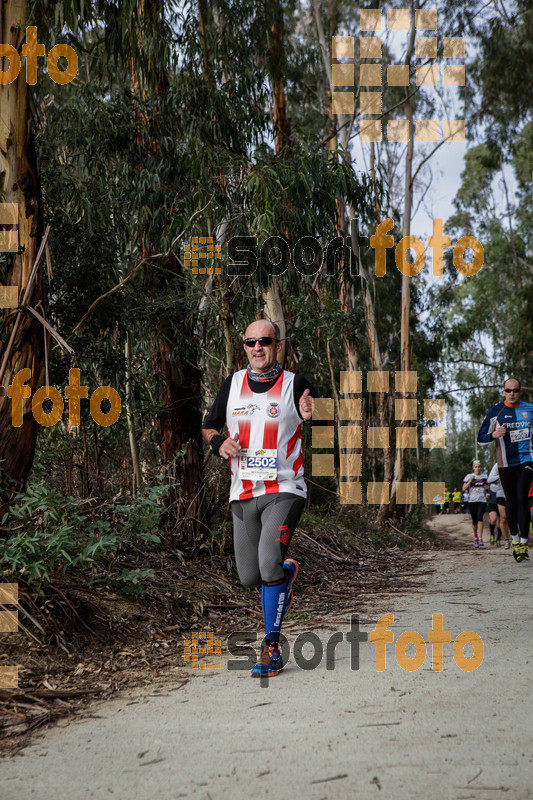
[0, 515, 533, 800]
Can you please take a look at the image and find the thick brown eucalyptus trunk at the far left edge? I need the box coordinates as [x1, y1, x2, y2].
[0, 0, 44, 506]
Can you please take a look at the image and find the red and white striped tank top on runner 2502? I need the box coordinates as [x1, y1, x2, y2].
[226, 369, 307, 503]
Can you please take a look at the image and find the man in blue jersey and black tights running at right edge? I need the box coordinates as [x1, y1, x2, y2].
[477, 378, 533, 561]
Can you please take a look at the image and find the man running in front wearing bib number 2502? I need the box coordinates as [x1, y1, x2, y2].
[202, 320, 316, 677]
